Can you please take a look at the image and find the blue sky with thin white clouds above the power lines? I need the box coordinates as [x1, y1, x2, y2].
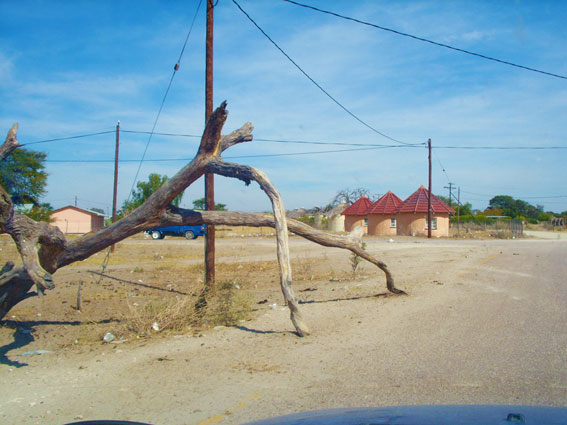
[0, 0, 567, 212]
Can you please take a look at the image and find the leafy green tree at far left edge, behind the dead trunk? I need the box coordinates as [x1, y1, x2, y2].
[0, 149, 47, 206]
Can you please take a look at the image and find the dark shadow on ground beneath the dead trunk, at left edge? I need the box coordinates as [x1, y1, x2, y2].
[0, 319, 119, 368]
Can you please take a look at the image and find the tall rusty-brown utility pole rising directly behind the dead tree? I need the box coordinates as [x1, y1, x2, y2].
[205, 0, 215, 289]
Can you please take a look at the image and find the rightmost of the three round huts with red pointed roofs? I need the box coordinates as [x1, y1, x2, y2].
[396, 186, 455, 237]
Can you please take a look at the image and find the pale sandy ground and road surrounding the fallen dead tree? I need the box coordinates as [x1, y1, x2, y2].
[0, 234, 567, 425]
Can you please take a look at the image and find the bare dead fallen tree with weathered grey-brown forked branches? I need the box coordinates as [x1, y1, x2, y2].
[0, 102, 404, 336]
